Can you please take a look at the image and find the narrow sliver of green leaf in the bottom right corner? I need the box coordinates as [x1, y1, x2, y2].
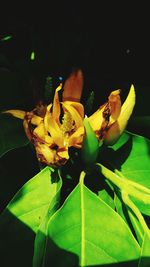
[138, 234, 150, 267]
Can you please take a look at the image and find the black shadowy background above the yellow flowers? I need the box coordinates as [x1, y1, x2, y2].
[0, 1, 150, 118]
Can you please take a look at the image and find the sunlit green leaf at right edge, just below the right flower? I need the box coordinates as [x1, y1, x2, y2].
[111, 132, 150, 188]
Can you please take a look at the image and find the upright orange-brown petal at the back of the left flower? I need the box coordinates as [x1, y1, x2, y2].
[62, 70, 83, 102]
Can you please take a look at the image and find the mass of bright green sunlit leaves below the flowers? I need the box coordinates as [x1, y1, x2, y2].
[0, 116, 150, 267]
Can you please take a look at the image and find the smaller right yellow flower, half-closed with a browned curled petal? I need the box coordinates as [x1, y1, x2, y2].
[88, 85, 135, 145]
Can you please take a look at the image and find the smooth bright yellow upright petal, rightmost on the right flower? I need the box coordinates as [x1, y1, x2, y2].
[104, 85, 136, 145]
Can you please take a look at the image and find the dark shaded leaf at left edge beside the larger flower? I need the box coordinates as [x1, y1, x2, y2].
[0, 114, 29, 157]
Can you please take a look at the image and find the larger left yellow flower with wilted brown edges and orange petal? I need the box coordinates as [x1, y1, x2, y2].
[5, 70, 84, 166]
